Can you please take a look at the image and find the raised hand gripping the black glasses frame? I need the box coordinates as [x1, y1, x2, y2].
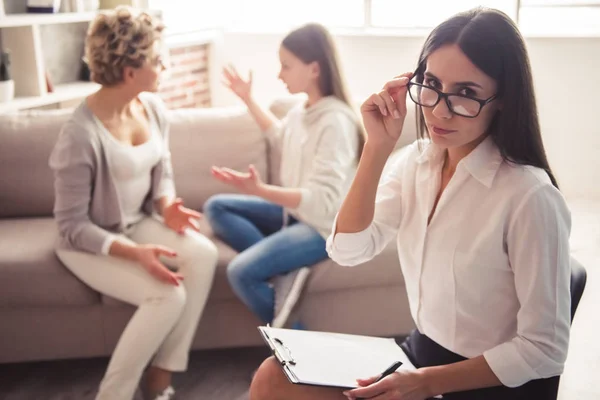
[360, 72, 412, 151]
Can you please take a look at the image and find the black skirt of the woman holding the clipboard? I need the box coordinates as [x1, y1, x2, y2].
[400, 329, 559, 400]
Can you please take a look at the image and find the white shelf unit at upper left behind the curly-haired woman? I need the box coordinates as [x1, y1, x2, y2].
[0, 12, 98, 113]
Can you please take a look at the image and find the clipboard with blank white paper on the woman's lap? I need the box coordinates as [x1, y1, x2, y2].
[258, 326, 415, 389]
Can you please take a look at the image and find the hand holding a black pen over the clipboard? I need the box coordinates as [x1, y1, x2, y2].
[344, 370, 433, 400]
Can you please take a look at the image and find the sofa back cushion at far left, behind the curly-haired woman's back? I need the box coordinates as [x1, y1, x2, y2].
[0, 110, 71, 218]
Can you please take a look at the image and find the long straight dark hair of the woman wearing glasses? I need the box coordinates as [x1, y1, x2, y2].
[416, 7, 558, 188]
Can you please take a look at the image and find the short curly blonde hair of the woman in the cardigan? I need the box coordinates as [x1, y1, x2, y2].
[84, 6, 164, 86]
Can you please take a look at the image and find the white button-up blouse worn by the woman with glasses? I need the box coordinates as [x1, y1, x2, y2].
[327, 137, 571, 387]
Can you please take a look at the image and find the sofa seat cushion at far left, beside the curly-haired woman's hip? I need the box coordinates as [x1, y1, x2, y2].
[0, 218, 100, 307]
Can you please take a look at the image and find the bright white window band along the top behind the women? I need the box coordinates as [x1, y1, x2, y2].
[151, 0, 600, 35]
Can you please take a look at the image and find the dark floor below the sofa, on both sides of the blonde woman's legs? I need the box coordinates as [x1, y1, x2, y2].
[0, 348, 268, 400]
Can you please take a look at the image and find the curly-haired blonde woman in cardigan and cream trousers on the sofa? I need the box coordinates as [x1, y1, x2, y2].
[50, 8, 217, 400]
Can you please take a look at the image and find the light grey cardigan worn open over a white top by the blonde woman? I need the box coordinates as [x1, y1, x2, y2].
[49, 93, 175, 254]
